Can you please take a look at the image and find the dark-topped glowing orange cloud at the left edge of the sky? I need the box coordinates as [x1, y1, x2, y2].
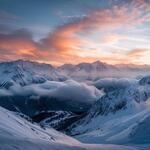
[0, 29, 37, 59]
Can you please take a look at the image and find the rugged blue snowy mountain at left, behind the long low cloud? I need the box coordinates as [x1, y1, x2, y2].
[0, 60, 67, 88]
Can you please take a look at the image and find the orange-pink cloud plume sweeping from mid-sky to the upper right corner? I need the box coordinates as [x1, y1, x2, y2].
[42, 0, 150, 53]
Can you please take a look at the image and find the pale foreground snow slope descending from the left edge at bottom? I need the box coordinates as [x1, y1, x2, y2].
[0, 107, 80, 149]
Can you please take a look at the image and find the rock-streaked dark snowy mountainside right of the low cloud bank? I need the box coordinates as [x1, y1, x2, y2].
[83, 86, 150, 121]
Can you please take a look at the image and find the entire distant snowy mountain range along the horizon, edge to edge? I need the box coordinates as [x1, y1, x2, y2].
[0, 60, 150, 85]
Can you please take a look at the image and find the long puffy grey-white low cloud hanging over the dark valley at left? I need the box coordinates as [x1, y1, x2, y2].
[0, 80, 102, 103]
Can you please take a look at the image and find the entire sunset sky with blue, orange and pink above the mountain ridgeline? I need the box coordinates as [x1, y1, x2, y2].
[0, 0, 150, 66]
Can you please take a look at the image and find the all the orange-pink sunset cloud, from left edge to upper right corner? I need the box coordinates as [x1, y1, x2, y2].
[0, 0, 150, 65]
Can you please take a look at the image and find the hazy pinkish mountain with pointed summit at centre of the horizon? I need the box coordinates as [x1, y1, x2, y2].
[58, 61, 118, 80]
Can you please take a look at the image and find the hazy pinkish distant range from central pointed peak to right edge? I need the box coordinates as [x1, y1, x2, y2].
[58, 61, 150, 80]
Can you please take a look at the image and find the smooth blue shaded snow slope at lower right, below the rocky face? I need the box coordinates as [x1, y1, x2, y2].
[72, 102, 150, 144]
